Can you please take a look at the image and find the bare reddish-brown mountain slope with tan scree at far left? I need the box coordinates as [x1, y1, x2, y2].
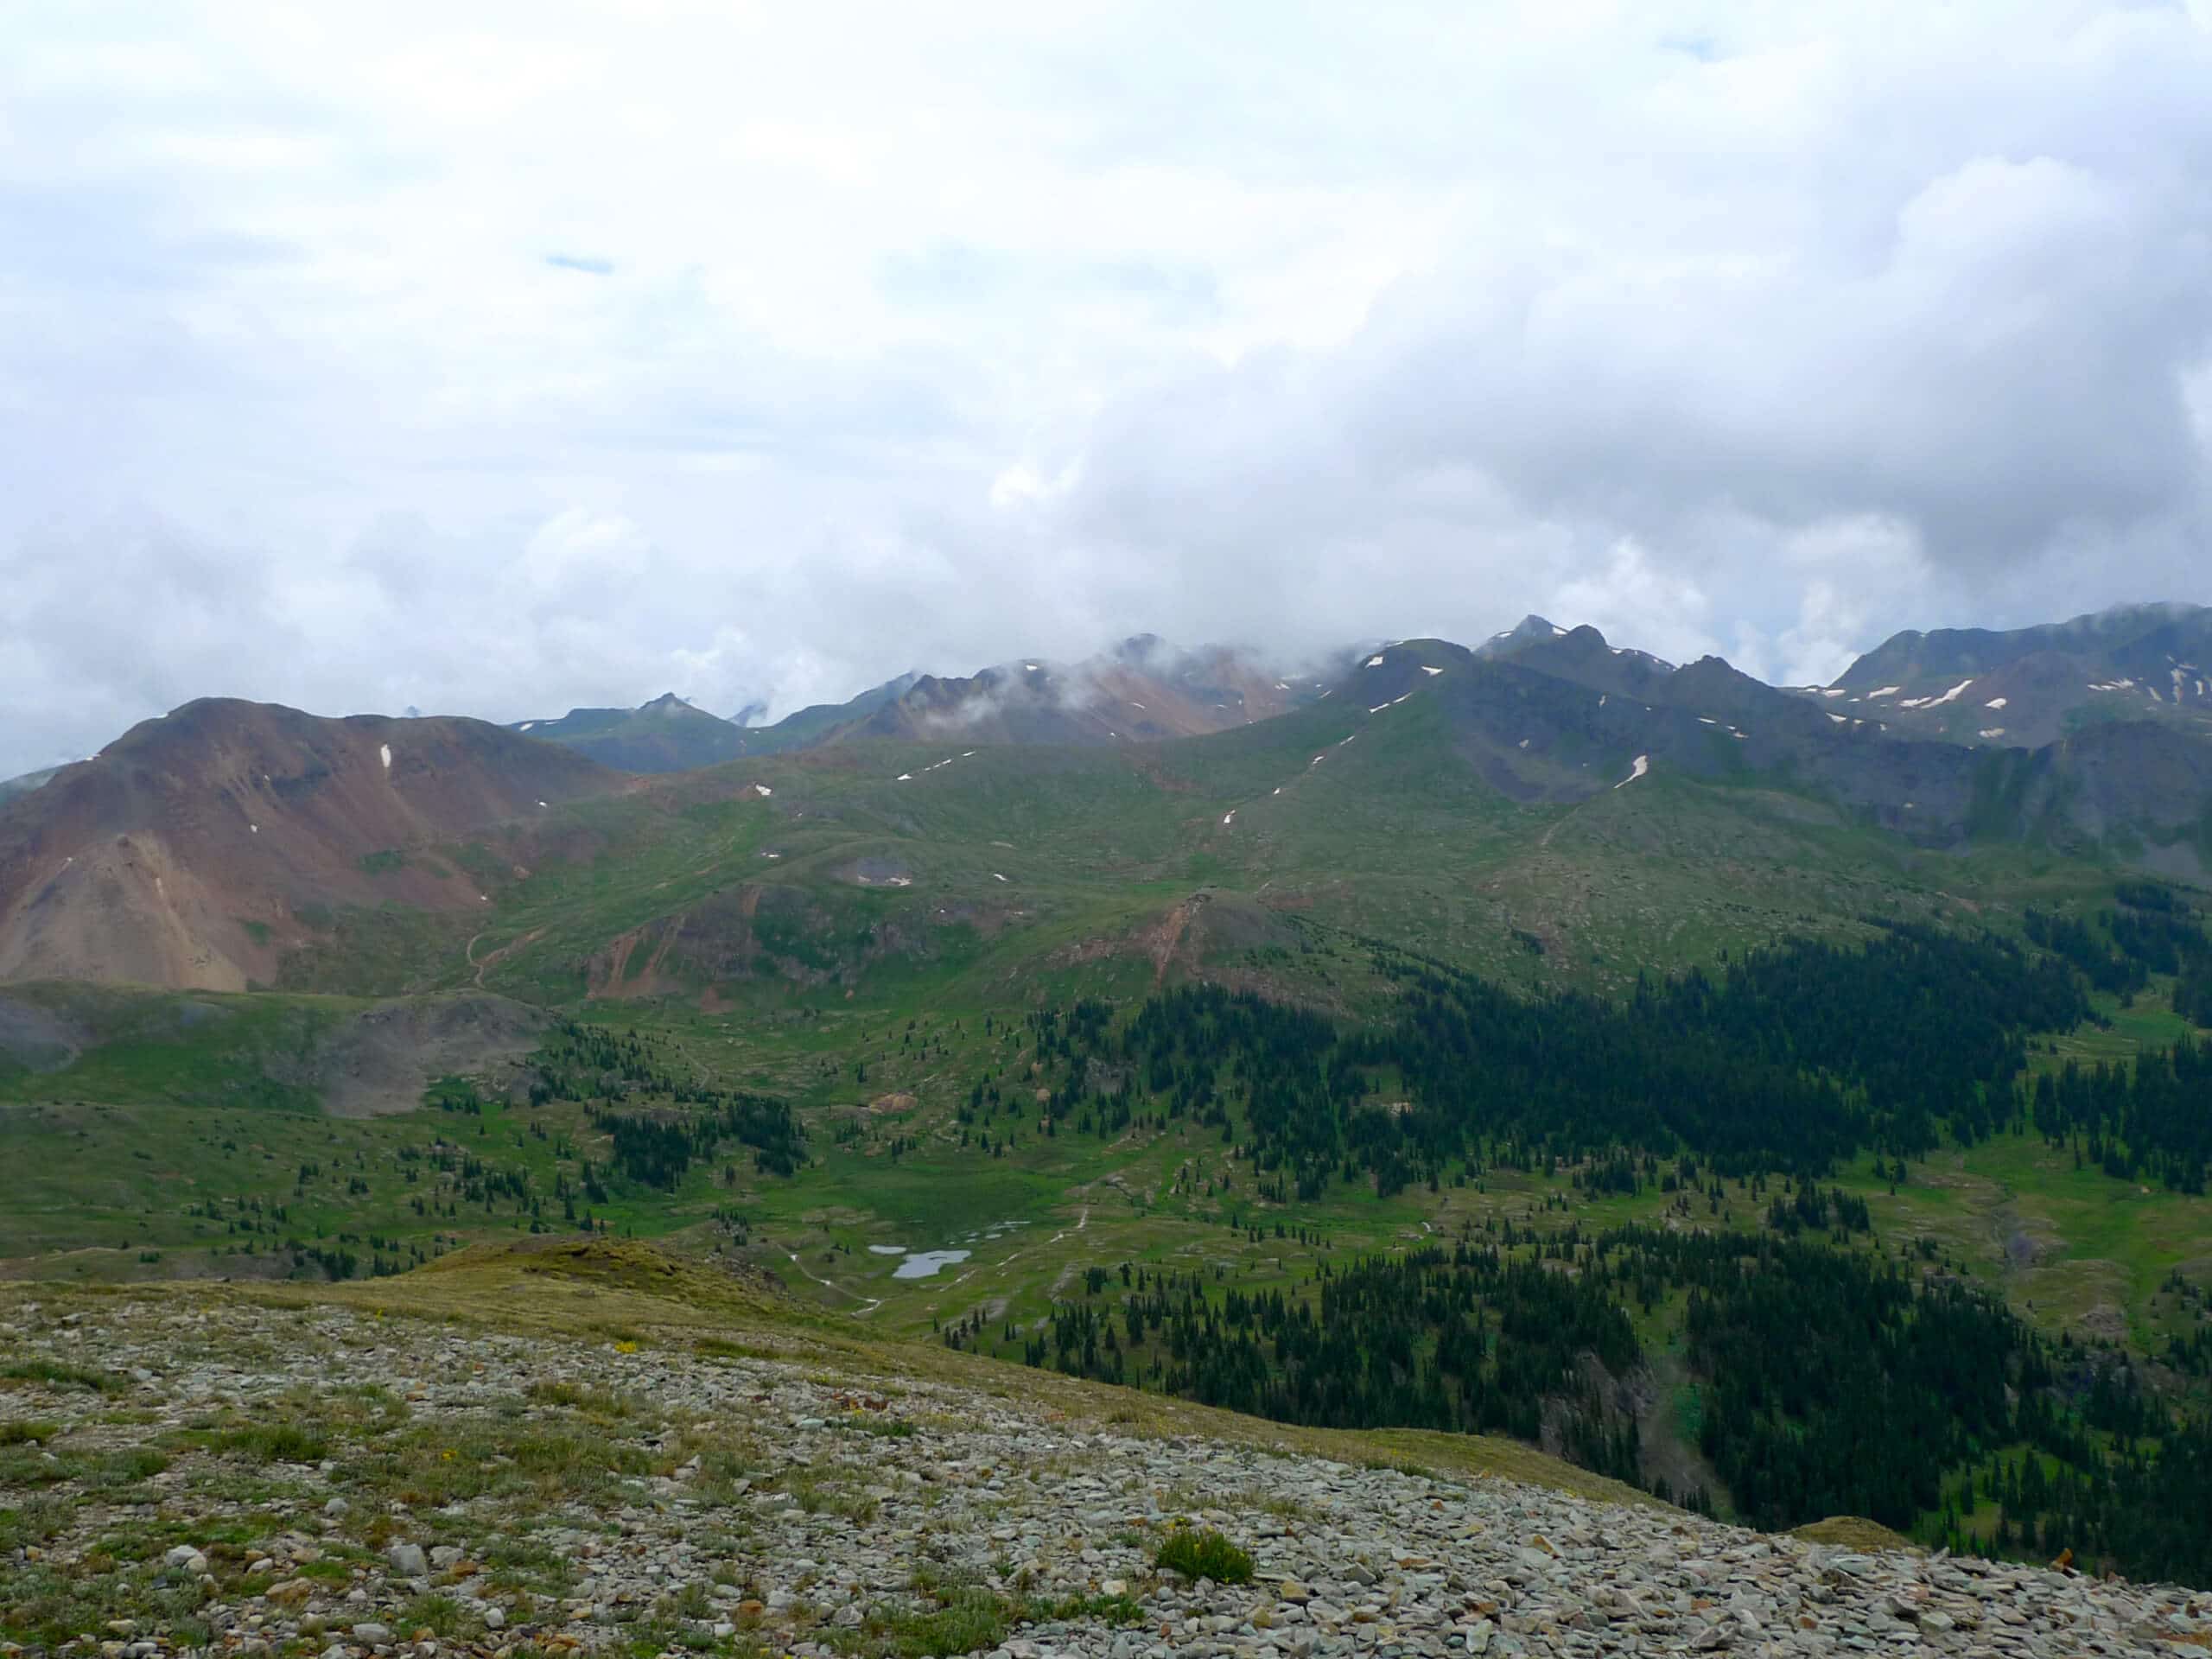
[0, 699, 626, 988]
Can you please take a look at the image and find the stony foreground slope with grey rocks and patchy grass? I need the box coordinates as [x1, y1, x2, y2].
[0, 1299, 2212, 1659]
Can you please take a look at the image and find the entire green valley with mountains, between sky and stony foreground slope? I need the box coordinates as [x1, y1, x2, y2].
[13, 613, 2212, 1659]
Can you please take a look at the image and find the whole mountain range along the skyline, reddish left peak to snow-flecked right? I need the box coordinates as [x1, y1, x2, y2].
[0, 606, 2212, 988]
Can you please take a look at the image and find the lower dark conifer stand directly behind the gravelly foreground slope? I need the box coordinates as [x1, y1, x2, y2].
[1000, 1225, 2212, 1584]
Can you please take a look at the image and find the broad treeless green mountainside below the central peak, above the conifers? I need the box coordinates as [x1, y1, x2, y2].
[258, 672, 2141, 1007]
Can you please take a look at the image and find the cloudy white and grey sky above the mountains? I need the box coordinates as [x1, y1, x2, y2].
[0, 0, 2212, 777]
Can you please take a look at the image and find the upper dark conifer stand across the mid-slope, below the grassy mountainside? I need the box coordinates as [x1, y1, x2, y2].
[1017, 927, 2088, 1201]
